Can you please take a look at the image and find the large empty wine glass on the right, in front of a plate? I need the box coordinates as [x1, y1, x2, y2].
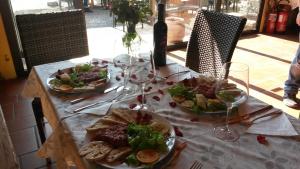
[214, 62, 249, 141]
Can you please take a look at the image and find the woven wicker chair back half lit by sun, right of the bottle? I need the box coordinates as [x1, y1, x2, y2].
[186, 10, 247, 76]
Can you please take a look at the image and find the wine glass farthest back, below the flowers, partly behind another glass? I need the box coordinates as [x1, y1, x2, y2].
[113, 54, 135, 97]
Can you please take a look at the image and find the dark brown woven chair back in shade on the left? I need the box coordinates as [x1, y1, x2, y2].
[16, 10, 89, 70]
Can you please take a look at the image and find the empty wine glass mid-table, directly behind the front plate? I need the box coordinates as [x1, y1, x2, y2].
[130, 54, 155, 112]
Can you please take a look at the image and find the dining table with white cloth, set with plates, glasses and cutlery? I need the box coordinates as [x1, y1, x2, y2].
[23, 52, 300, 169]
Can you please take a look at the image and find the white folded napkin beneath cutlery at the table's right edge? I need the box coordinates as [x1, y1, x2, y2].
[239, 97, 299, 136]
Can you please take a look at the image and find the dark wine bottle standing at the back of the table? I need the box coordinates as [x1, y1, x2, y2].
[153, 3, 168, 67]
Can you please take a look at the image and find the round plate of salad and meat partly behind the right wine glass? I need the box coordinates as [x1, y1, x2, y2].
[168, 75, 226, 115]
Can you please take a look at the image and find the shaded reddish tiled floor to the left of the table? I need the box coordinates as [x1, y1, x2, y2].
[0, 79, 51, 169]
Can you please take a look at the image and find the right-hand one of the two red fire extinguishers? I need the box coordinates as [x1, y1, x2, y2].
[276, 4, 291, 33]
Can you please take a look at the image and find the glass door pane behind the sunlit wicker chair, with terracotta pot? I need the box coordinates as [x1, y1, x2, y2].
[166, 0, 262, 44]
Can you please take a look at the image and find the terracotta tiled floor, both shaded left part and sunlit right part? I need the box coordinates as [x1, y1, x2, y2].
[0, 31, 299, 169]
